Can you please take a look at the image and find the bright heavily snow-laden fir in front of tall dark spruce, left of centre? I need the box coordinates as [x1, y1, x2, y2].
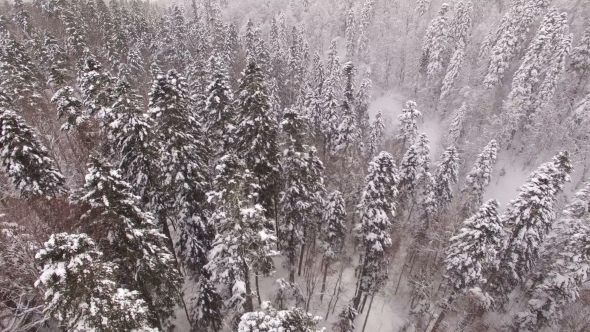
[206, 155, 276, 313]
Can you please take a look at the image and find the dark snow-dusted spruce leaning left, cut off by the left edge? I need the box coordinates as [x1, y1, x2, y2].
[0, 109, 65, 197]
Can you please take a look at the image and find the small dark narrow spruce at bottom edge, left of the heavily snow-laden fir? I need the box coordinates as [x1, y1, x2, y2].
[191, 269, 223, 332]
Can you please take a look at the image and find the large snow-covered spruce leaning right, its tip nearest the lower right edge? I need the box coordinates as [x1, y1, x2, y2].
[488, 152, 572, 306]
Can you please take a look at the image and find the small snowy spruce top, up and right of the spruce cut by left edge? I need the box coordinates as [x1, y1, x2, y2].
[51, 86, 89, 132]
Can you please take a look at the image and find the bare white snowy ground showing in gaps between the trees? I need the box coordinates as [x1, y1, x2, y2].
[175, 91, 581, 332]
